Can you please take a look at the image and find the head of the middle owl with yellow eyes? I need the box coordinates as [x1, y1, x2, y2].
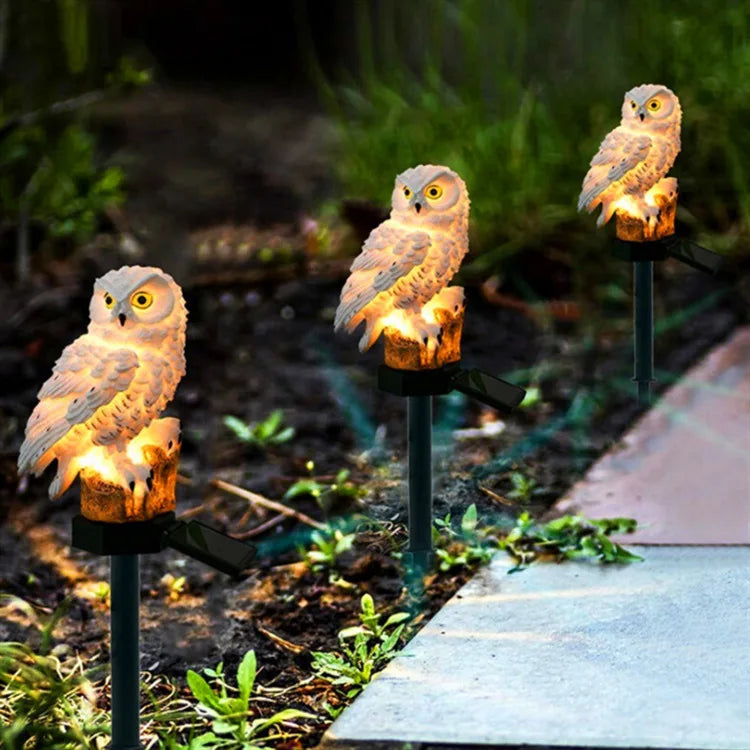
[391, 164, 469, 223]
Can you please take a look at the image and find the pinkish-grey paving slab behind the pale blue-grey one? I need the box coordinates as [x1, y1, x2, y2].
[554, 327, 750, 544]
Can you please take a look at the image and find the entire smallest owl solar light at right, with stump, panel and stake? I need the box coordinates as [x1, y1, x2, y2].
[578, 84, 722, 405]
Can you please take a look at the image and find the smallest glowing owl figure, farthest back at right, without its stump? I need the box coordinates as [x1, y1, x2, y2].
[578, 83, 682, 226]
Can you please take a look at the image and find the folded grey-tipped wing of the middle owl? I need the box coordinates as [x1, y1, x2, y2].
[334, 222, 432, 330]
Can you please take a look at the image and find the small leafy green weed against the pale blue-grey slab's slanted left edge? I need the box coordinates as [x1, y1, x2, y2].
[312, 594, 409, 698]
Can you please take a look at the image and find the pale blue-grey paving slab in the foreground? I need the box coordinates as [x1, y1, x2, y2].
[326, 547, 750, 750]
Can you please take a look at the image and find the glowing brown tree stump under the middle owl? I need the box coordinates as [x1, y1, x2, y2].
[383, 304, 465, 370]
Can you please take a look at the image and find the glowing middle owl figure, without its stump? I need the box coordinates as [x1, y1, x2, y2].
[334, 164, 469, 351]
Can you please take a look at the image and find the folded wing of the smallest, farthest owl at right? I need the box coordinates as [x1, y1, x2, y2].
[578, 128, 653, 212]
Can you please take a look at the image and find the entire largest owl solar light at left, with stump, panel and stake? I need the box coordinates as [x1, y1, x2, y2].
[18, 266, 254, 750]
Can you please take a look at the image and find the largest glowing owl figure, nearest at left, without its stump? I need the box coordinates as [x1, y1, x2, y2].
[18, 266, 187, 499]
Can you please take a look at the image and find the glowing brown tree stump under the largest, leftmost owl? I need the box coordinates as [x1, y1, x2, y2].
[80, 445, 180, 523]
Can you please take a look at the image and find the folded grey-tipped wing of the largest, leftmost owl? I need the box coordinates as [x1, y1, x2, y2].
[18, 335, 138, 474]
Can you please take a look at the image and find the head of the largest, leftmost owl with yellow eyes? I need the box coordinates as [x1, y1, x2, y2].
[89, 266, 187, 340]
